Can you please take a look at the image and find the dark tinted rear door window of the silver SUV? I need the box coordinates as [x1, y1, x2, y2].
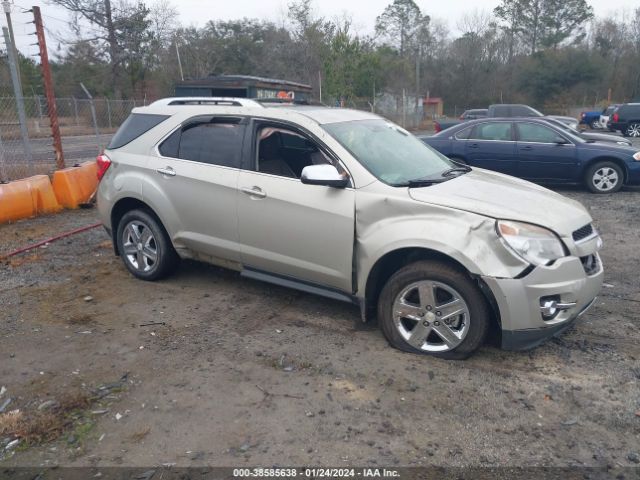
[158, 118, 245, 168]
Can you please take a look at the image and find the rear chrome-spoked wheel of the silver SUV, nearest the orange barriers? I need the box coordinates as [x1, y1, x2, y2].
[116, 210, 180, 281]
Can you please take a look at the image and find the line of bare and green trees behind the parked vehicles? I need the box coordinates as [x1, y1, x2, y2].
[0, 0, 640, 111]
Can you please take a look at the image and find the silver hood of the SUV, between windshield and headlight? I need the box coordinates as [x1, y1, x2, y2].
[409, 168, 592, 237]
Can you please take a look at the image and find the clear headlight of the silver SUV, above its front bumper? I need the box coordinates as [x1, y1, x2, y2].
[496, 220, 567, 266]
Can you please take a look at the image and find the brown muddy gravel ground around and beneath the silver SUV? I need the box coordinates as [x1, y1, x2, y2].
[0, 177, 640, 472]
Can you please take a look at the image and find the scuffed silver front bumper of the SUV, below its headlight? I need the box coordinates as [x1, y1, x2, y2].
[482, 254, 604, 350]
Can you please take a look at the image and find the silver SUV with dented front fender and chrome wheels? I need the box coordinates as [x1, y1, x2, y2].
[98, 98, 603, 359]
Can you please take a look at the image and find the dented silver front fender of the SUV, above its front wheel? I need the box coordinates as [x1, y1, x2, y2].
[355, 183, 529, 298]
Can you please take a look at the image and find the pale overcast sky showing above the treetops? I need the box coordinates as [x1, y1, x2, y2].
[5, 0, 640, 59]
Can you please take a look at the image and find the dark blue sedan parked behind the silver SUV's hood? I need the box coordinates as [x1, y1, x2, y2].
[421, 118, 640, 193]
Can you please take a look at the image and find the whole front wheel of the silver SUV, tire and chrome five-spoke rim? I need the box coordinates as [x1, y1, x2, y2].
[378, 261, 489, 360]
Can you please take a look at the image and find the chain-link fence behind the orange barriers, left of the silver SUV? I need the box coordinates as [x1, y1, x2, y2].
[0, 95, 145, 182]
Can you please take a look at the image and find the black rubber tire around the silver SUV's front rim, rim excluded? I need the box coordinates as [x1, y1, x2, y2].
[378, 261, 490, 360]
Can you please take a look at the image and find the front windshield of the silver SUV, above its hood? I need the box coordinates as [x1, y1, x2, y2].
[323, 119, 456, 186]
